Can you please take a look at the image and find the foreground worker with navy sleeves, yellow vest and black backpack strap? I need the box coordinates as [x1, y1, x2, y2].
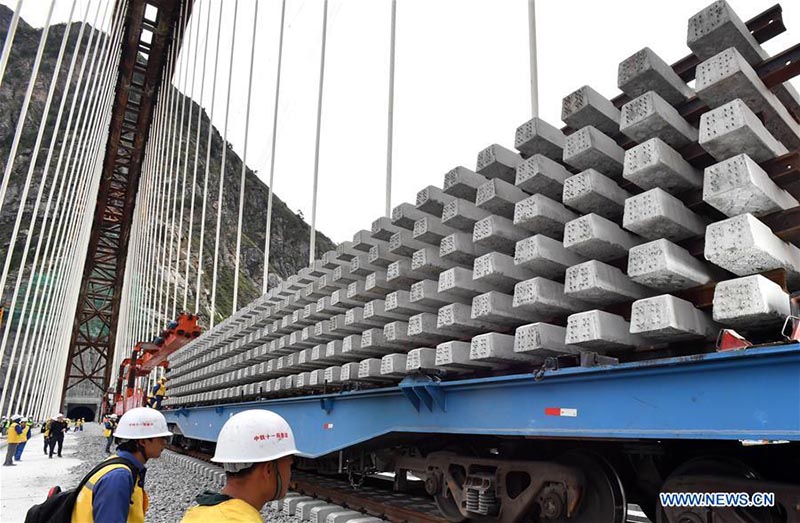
[72, 407, 172, 523]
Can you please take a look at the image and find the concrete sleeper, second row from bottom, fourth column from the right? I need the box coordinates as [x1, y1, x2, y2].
[513, 277, 590, 321]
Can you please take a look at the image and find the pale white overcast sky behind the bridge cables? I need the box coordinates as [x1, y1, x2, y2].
[6, 0, 800, 246]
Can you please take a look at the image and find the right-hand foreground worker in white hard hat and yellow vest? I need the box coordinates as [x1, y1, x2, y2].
[181, 409, 297, 523]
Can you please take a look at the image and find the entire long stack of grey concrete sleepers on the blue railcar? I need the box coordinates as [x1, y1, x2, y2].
[166, 2, 800, 406]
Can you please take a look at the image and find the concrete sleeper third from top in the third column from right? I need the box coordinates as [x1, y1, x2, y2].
[562, 169, 631, 220]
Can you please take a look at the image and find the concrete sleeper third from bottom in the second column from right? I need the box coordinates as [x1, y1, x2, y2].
[622, 187, 706, 241]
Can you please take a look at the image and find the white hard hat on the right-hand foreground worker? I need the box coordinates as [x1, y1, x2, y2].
[211, 409, 298, 466]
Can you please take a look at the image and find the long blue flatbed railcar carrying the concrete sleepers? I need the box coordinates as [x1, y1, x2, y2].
[165, 343, 800, 522]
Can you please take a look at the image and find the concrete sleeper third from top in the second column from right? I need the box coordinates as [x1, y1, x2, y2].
[622, 138, 703, 194]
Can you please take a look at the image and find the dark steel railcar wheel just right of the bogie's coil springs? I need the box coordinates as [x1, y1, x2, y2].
[558, 451, 628, 523]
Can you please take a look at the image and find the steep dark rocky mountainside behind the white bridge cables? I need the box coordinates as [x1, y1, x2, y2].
[0, 5, 335, 336]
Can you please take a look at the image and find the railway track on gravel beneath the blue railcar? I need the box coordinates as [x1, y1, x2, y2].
[168, 445, 649, 523]
